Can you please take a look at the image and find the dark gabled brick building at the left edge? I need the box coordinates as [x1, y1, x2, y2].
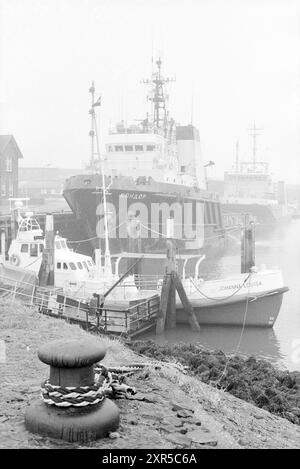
[0, 135, 23, 204]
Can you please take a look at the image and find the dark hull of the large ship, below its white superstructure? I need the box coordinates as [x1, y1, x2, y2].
[63, 175, 224, 274]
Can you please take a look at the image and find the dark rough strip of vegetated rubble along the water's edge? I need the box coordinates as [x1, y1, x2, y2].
[127, 340, 300, 425]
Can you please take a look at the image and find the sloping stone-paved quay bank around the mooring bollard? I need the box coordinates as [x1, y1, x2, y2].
[0, 301, 300, 450]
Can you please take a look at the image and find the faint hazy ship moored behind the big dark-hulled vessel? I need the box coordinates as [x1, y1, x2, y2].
[222, 123, 290, 228]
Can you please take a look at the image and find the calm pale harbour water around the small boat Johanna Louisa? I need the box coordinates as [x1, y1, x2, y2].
[141, 220, 300, 371]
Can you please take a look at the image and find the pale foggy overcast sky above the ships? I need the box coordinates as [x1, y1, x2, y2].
[0, 0, 300, 183]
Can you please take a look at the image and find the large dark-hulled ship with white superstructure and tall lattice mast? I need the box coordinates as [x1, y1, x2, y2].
[63, 59, 224, 273]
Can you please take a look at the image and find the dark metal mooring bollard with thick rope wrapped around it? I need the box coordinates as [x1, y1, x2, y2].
[25, 339, 120, 443]
